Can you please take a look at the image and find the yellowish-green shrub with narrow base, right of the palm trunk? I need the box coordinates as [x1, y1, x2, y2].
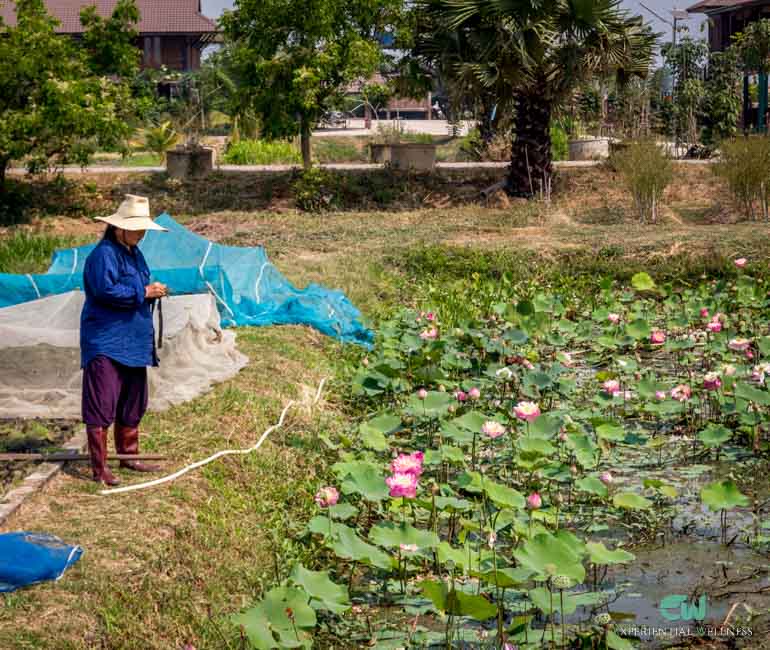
[612, 140, 673, 223]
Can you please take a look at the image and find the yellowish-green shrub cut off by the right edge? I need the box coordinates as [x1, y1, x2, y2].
[714, 136, 770, 220]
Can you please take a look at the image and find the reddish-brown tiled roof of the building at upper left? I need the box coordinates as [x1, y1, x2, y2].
[0, 0, 218, 34]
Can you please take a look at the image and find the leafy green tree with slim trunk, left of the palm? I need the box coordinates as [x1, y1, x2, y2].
[221, 0, 402, 169]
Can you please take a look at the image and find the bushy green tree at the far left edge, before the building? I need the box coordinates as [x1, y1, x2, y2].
[0, 0, 140, 187]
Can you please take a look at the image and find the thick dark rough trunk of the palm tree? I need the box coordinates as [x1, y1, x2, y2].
[506, 95, 553, 197]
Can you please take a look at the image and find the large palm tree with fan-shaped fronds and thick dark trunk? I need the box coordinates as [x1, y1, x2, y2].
[414, 0, 657, 196]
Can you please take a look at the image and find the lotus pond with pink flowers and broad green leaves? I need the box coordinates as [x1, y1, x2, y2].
[232, 259, 770, 650]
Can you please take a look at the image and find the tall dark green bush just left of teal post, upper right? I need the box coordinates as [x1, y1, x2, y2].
[701, 48, 742, 147]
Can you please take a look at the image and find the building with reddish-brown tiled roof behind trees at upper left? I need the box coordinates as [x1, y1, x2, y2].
[0, 0, 218, 72]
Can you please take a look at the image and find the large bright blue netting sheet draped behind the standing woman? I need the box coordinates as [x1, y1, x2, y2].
[0, 213, 372, 346]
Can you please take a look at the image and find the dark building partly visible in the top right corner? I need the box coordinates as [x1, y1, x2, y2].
[687, 0, 770, 131]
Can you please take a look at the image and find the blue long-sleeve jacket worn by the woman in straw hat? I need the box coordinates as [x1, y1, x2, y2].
[80, 239, 158, 368]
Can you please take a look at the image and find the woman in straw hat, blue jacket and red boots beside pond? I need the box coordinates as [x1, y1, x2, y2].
[80, 194, 168, 485]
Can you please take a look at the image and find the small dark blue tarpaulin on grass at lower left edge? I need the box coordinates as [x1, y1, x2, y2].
[0, 532, 83, 592]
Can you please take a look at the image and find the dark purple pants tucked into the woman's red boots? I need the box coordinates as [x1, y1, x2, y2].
[83, 356, 149, 429]
